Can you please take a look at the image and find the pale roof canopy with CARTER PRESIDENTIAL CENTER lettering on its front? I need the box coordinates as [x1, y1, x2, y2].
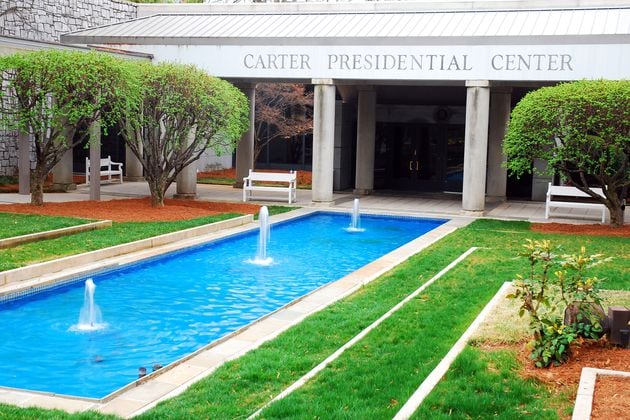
[62, 7, 630, 81]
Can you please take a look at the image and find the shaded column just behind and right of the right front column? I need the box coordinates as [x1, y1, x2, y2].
[487, 88, 512, 201]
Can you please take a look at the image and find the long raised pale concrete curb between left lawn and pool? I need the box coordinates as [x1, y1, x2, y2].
[0, 214, 254, 286]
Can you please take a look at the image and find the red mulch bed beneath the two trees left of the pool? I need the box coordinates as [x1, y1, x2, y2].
[0, 197, 260, 222]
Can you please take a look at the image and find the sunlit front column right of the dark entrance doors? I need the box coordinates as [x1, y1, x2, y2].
[462, 80, 490, 215]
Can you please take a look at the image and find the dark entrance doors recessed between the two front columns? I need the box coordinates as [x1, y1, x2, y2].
[374, 122, 464, 192]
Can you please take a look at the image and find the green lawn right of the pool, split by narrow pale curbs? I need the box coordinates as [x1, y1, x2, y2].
[0, 220, 630, 419]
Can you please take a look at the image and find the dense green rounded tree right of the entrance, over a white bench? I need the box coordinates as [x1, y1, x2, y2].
[504, 80, 630, 226]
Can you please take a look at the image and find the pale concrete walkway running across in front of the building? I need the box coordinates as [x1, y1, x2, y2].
[0, 182, 630, 224]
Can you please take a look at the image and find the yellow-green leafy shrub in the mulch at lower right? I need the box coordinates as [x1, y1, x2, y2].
[508, 239, 610, 367]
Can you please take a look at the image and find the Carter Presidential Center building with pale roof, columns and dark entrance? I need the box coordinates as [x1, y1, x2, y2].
[1, 0, 630, 214]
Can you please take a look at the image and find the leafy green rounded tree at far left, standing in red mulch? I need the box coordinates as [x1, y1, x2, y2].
[0, 50, 132, 205]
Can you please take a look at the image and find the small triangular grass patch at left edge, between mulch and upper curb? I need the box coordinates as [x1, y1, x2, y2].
[0, 212, 93, 239]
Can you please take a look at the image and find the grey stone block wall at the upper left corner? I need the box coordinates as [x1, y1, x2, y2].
[0, 0, 137, 176]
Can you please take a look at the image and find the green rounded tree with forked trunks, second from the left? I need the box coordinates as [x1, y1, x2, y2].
[121, 63, 249, 207]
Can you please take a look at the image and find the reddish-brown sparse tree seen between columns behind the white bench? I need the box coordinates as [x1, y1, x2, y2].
[254, 83, 313, 162]
